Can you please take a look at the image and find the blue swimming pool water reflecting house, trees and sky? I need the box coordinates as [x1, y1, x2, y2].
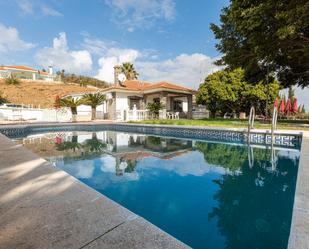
[16, 131, 300, 249]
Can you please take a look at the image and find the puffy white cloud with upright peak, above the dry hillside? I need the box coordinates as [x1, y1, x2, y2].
[35, 32, 92, 73]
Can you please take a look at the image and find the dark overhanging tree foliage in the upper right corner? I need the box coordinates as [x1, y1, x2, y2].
[211, 0, 309, 87]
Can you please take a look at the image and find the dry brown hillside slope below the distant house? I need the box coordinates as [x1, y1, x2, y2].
[0, 79, 98, 108]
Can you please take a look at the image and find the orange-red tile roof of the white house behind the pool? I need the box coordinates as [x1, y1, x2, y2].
[106, 80, 194, 92]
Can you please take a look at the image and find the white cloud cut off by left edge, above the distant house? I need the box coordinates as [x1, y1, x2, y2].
[0, 23, 35, 53]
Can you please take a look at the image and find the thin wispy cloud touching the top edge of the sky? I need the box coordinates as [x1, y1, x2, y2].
[105, 0, 176, 32]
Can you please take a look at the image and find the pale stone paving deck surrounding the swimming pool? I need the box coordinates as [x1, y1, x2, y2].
[0, 124, 309, 249]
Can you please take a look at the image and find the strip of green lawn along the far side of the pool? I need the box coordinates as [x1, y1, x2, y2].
[130, 119, 309, 130]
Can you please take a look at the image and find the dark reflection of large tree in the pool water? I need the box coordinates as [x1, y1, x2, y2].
[208, 152, 298, 248]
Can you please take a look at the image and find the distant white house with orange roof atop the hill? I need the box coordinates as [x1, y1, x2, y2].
[0, 66, 59, 81]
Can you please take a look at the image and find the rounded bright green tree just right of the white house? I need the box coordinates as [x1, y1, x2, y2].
[196, 68, 279, 117]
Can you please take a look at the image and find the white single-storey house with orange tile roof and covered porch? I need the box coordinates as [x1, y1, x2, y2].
[101, 80, 195, 120]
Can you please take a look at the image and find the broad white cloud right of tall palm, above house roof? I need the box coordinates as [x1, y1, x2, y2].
[136, 53, 220, 89]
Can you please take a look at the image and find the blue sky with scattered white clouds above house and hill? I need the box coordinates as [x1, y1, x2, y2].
[0, 0, 228, 88]
